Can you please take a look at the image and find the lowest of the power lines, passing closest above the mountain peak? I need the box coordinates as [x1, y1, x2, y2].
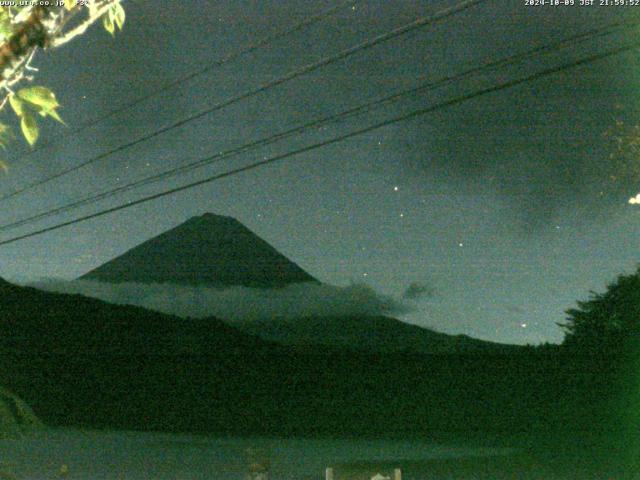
[0, 42, 640, 246]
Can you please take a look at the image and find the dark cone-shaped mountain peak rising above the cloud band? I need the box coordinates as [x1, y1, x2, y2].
[80, 213, 317, 288]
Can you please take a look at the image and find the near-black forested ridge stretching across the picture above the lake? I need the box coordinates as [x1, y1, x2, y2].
[0, 281, 626, 456]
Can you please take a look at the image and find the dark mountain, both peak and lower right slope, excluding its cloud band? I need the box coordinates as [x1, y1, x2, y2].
[76, 213, 513, 354]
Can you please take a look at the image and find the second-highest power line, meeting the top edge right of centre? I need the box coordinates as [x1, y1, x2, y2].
[0, 0, 488, 201]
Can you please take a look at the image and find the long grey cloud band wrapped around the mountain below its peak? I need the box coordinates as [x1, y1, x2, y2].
[31, 279, 411, 322]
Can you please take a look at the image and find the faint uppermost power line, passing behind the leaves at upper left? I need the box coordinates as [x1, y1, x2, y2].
[0, 0, 354, 174]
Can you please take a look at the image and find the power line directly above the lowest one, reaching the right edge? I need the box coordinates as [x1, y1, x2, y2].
[0, 15, 640, 232]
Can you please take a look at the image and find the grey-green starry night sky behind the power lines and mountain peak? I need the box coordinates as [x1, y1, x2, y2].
[0, 0, 640, 343]
